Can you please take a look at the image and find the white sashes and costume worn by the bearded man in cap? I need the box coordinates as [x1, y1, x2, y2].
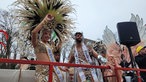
[71, 43, 100, 82]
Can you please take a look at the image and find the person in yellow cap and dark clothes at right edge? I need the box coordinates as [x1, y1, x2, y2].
[135, 46, 146, 82]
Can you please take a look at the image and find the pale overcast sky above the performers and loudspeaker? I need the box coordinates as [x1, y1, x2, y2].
[0, 0, 146, 40]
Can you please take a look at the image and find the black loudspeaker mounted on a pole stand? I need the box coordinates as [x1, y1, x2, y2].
[117, 22, 140, 46]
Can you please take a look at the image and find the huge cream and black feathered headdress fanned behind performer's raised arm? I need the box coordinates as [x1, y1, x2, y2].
[14, 0, 73, 47]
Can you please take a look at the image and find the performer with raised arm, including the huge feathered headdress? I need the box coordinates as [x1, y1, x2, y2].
[14, 0, 73, 82]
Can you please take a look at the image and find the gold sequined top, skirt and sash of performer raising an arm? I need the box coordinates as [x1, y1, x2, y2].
[35, 41, 63, 82]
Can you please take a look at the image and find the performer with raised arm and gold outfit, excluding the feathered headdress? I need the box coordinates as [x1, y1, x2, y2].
[31, 15, 63, 82]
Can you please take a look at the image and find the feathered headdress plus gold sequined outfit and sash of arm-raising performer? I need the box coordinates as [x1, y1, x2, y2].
[14, 0, 73, 82]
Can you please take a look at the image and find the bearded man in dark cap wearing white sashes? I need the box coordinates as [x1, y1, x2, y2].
[69, 32, 107, 82]
